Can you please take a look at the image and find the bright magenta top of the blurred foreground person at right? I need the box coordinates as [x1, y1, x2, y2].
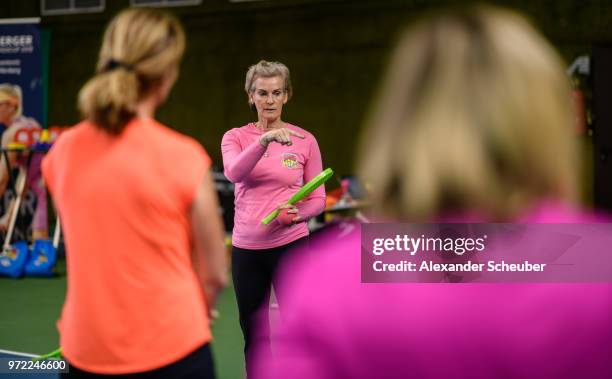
[255, 206, 612, 379]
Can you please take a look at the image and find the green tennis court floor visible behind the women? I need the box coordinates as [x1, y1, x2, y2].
[0, 260, 244, 379]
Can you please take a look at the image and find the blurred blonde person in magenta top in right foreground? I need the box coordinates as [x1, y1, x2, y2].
[256, 7, 612, 379]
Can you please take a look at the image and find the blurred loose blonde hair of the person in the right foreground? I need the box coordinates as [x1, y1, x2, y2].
[360, 7, 577, 221]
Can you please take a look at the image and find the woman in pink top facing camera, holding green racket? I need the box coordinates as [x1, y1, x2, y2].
[221, 61, 325, 378]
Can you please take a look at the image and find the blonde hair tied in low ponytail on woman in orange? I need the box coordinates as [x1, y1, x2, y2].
[79, 8, 185, 134]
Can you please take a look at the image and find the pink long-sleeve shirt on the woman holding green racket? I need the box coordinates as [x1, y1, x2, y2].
[221, 123, 325, 250]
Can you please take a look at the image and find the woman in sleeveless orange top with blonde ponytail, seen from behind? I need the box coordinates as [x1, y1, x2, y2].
[43, 8, 227, 378]
